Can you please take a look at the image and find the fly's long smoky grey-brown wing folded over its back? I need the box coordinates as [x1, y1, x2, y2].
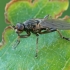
[40, 19, 70, 30]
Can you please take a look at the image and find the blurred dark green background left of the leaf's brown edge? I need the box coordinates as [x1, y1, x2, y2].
[0, 0, 10, 41]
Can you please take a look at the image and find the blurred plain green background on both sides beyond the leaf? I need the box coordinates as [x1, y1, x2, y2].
[0, 0, 70, 41]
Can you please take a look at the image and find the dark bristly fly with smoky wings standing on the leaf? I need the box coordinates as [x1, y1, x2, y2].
[6, 16, 70, 57]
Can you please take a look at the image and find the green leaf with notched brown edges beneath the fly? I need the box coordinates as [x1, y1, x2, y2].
[0, 0, 70, 70]
